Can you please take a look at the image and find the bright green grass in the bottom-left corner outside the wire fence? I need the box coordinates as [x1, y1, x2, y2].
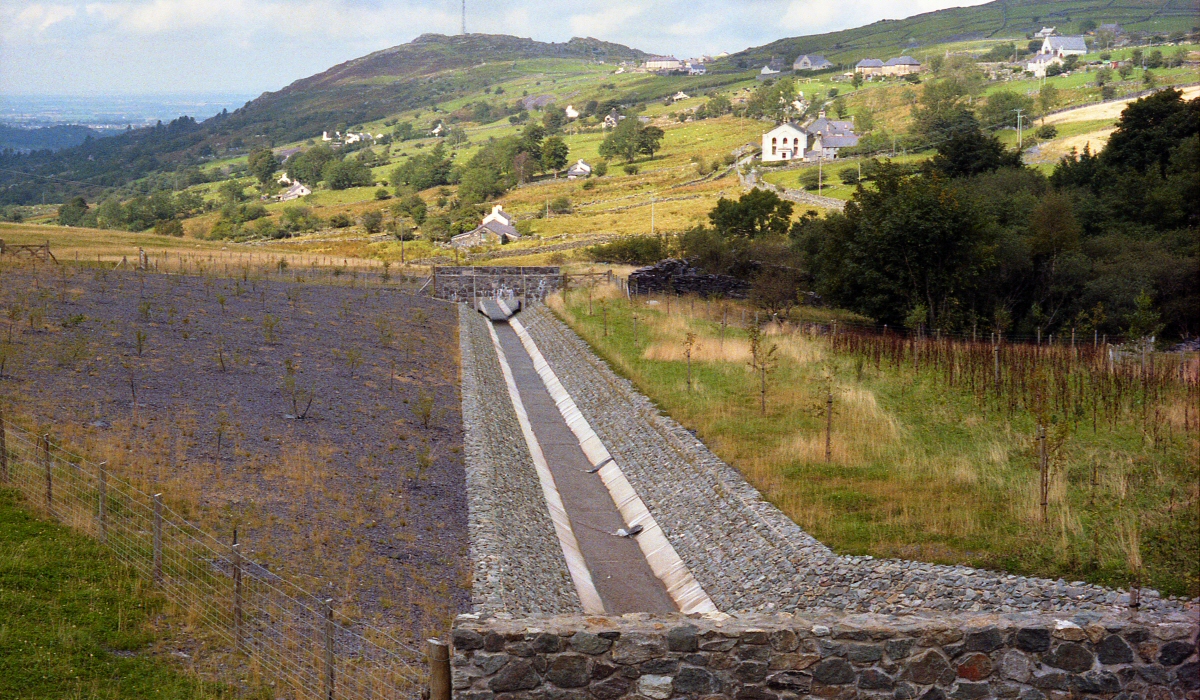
[0, 489, 234, 700]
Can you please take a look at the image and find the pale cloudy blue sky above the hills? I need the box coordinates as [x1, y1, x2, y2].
[0, 0, 985, 96]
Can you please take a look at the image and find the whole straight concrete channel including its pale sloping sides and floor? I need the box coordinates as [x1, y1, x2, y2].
[476, 299, 716, 615]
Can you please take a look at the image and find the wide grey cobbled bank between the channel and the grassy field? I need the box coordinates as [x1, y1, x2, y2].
[516, 305, 1195, 614]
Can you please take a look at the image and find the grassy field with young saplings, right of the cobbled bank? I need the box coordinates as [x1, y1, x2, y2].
[552, 283, 1200, 596]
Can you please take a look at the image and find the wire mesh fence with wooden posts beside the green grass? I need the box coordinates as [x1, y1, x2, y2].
[0, 415, 427, 700]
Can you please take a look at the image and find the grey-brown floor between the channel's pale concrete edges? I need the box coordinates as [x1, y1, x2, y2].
[488, 315, 678, 615]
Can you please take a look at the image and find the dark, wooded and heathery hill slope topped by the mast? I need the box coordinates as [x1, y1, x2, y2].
[0, 34, 646, 203]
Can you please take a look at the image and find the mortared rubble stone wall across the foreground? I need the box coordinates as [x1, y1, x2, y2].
[451, 614, 1200, 700]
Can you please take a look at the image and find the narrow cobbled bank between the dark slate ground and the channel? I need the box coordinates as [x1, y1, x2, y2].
[458, 304, 582, 617]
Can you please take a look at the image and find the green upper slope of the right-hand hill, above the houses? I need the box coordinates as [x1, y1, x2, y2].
[713, 0, 1200, 71]
